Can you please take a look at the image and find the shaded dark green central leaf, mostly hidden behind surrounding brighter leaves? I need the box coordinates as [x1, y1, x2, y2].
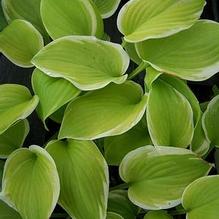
[104, 118, 152, 165]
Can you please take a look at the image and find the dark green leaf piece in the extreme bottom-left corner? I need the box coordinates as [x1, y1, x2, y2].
[0, 199, 22, 219]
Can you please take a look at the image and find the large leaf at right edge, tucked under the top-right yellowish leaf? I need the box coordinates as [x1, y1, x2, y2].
[137, 20, 219, 81]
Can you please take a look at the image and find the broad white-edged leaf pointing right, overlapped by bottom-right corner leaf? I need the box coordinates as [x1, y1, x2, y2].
[120, 146, 211, 210]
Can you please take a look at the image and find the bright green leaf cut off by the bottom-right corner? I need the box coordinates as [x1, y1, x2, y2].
[182, 175, 219, 219]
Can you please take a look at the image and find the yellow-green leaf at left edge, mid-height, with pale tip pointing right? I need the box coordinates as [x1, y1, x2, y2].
[0, 84, 39, 134]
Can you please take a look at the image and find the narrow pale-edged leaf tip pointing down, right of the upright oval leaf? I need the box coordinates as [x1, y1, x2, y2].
[190, 114, 210, 156]
